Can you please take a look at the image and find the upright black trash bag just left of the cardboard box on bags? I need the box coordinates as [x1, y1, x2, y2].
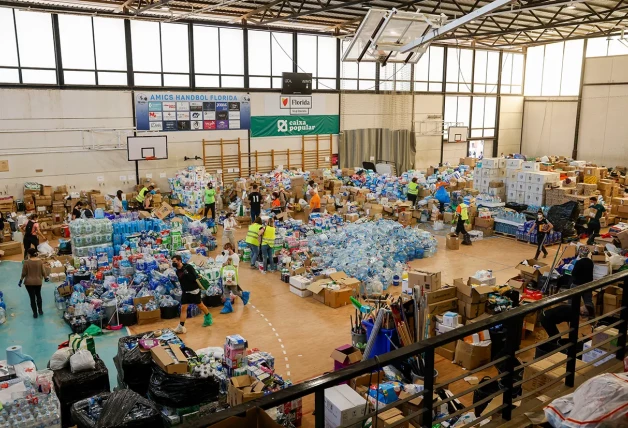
[114, 333, 153, 395]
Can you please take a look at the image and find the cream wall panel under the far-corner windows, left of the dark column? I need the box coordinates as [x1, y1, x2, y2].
[520, 97, 578, 156]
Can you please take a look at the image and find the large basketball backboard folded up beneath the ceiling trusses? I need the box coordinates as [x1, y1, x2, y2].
[342, 8, 446, 64]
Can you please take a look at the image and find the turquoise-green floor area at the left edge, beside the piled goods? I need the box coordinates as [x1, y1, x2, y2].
[0, 261, 127, 389]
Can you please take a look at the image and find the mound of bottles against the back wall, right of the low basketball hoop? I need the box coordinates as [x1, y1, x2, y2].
[168, 166, 218, 212]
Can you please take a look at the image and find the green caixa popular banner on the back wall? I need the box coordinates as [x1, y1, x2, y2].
[251, 115, 340, 137]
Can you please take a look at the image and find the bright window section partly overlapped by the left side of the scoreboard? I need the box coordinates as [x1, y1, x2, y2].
[248, 31, 294, 88]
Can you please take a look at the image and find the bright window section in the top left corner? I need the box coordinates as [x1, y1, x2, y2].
[0, 8, 57, 84]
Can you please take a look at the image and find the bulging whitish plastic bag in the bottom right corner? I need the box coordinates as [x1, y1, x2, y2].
[543, 373, 628, 428]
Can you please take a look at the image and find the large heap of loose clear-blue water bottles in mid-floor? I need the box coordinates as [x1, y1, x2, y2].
[308, 220, 437, 287]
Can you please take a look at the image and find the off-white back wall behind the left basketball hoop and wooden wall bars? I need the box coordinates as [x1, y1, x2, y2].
[0, 89, 338, 197]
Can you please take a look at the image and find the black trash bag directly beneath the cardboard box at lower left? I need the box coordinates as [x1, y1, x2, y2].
[148, 367, 220, 408]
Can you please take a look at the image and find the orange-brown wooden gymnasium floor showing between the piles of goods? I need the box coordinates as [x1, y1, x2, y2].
[8, 226, 580, 428]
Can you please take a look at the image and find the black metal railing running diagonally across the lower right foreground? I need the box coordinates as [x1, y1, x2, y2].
[197, 271, 628, 428]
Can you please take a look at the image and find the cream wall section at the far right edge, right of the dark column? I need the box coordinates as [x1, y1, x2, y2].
[578, 56, 628, 166]
